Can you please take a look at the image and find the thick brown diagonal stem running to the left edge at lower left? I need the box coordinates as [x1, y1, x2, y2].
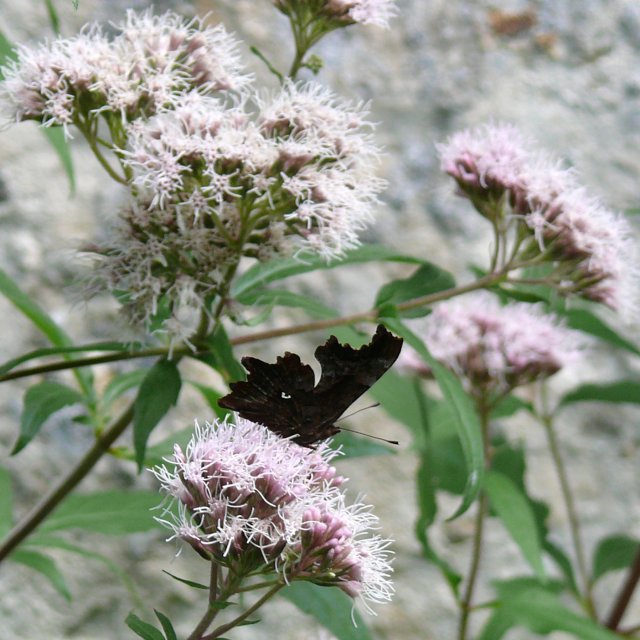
[0, 403, 133, 562]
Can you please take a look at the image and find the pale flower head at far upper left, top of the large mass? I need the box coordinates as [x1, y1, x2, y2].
[0, 10, 249, 130]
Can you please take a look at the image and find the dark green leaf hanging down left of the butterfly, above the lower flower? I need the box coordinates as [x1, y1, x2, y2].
[133, 360, 182, 470]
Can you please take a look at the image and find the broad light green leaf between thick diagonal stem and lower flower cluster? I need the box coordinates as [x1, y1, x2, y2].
[39, 491, 160, 535]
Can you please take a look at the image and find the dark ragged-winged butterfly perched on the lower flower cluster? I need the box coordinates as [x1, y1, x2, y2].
[218, 325, 403, 447]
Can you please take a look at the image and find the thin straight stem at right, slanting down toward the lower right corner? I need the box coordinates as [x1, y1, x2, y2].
[540, 384, 597, 620]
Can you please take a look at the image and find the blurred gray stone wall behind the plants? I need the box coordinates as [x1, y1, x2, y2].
[0, 0, 640, 640]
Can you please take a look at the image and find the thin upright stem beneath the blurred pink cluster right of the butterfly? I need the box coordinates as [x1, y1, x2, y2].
[458, 397, 491, 640]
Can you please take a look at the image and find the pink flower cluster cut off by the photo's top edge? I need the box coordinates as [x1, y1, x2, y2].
[273, 0, 397, 27]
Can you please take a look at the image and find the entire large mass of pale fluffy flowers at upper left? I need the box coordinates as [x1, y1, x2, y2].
[1, 12, 385, 340]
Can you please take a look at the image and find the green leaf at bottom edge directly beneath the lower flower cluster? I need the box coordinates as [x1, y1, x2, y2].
[280, 581, 371, 640]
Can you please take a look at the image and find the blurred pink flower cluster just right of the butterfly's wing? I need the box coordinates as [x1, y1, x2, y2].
[401, 292, 582, 395]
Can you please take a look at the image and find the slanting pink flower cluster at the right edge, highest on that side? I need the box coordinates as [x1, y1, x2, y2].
[438, 125, 638, 312]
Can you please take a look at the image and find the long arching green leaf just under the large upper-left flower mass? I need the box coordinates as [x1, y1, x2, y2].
[231, 245, 422, 298]
